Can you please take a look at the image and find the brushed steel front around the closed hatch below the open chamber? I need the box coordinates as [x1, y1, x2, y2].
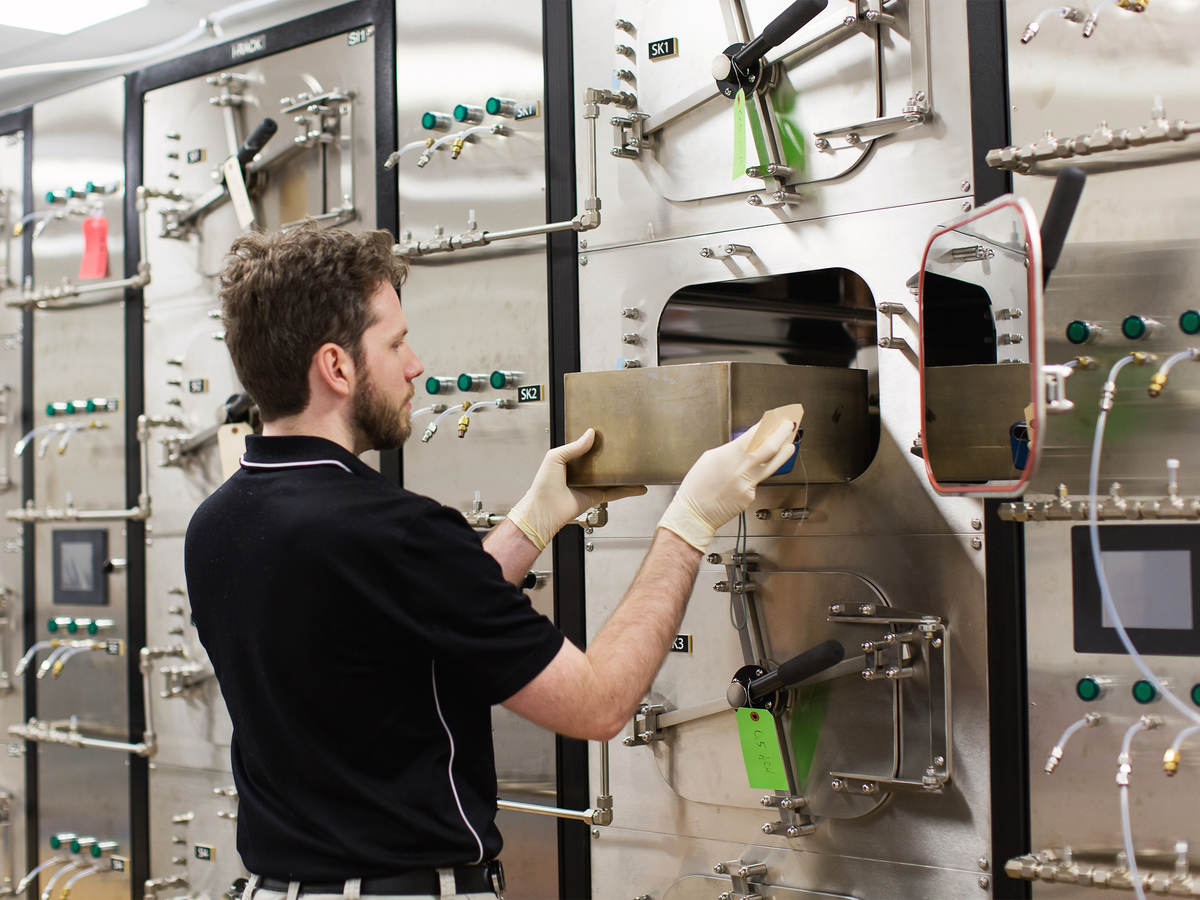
[587, 532, 991, 898]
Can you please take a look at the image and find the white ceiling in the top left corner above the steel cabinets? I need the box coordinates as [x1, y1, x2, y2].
[0, 0, 344, 112]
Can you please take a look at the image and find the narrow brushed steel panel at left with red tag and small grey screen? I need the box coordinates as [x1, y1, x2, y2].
[26, 78, 130, 898]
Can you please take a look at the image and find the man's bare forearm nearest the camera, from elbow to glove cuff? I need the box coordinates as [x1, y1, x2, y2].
[587, 528, 703, 734]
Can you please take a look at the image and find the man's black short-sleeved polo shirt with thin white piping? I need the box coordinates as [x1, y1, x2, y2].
[185, 437, 563, 881]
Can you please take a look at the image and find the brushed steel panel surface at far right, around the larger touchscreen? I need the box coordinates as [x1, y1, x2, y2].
[997, 0, 1200, 899]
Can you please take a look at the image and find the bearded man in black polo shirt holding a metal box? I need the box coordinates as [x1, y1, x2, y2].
[185, 229, 791, 900]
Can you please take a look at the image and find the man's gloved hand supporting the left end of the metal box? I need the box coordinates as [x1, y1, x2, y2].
[508, 428, 646, 550]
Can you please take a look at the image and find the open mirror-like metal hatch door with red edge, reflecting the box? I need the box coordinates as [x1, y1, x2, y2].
[918, 197, 1043, 497]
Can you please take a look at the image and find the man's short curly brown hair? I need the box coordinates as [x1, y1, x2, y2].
[220, 226, 408, 421]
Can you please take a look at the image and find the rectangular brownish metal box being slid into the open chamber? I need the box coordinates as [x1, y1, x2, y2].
[564, 362, 870, 485]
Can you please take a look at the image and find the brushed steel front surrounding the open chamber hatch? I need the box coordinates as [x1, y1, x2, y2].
[580, 196, 982, 542]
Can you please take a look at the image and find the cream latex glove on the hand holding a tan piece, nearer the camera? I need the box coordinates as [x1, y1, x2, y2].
[659, 422, 794, 551]
